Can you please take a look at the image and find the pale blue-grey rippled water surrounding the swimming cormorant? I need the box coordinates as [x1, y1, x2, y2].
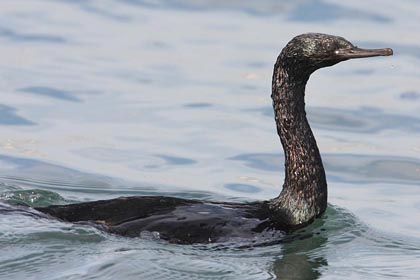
[0, 0, 420, 279]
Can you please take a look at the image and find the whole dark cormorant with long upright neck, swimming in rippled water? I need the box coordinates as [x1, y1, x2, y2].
[36, 33, 392, 244]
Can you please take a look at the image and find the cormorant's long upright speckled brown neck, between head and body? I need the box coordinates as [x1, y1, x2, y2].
[270, 61, 327, 227]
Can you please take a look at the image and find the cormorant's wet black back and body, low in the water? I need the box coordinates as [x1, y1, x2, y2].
[37, 196, 278, 244]
